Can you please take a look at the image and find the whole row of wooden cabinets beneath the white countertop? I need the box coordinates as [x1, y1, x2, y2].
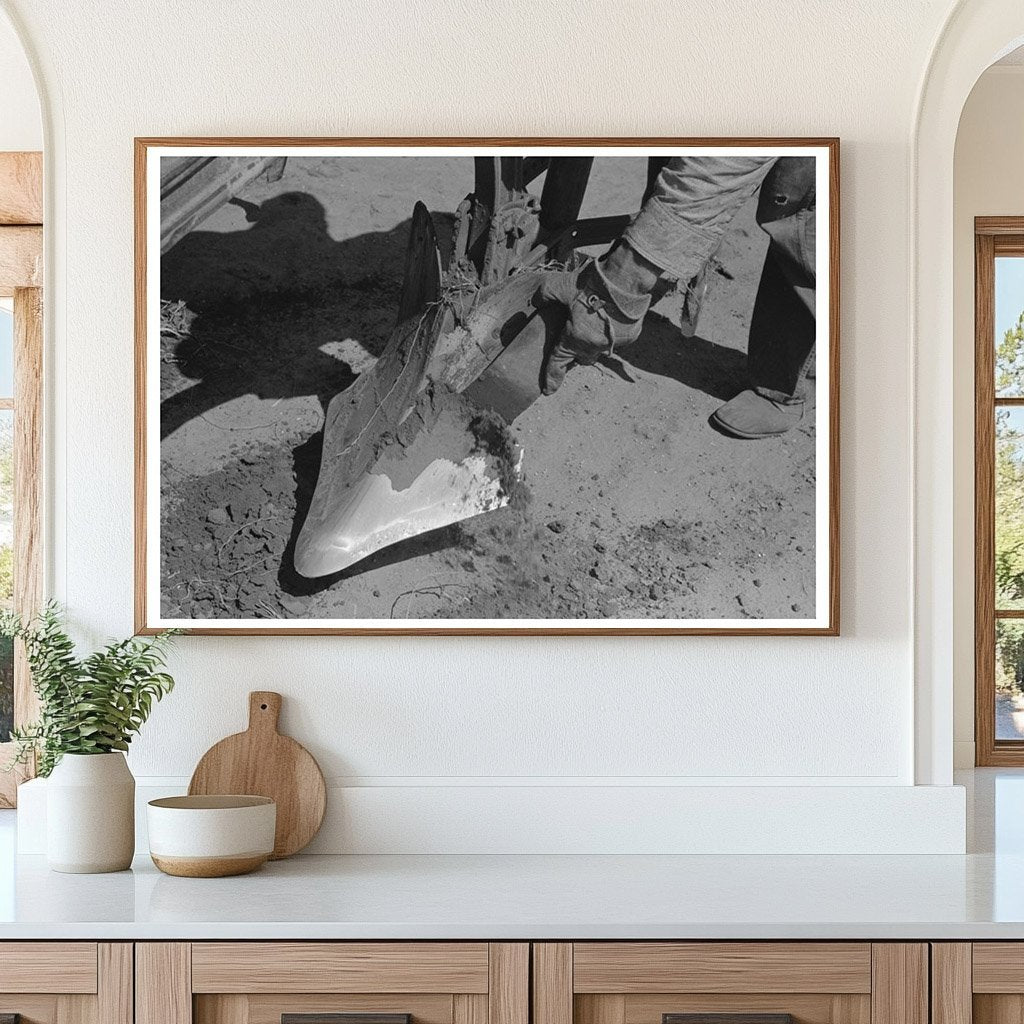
[0, 942, 970, 1024]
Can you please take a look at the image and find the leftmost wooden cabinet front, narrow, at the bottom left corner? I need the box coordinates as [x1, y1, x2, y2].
[0, 942, 132, 1024]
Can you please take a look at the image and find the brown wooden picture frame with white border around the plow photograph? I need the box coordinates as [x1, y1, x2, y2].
[135, 137, 840, 636]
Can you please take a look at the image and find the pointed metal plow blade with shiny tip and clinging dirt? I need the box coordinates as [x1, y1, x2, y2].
[295, 204, 520, 578]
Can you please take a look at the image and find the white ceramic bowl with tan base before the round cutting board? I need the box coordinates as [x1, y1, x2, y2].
[146, 795, 278, 879]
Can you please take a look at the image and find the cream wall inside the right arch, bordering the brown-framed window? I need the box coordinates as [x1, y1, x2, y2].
[953, 65, 1024, 767]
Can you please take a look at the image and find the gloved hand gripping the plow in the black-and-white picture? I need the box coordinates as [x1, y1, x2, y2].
[534, 242, 660, 394]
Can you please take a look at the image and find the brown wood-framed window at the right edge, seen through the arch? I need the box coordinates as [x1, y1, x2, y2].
[975, 217, 1024, 765]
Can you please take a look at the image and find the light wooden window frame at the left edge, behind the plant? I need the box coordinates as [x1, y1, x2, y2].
[0, 153, 43, 807]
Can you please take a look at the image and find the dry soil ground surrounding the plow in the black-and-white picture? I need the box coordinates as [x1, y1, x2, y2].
[161, 158, 815, 620]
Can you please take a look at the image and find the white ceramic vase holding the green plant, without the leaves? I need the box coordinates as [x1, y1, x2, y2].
[46, 753, 135, 874]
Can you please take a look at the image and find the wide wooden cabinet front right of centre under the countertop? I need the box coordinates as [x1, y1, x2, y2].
[534, 942, 928, 1024]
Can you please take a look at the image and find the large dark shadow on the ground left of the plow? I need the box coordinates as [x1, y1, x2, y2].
[160, 193, 452, 437]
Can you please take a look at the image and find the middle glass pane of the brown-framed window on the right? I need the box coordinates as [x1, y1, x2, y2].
[995, 407, 1024, 609]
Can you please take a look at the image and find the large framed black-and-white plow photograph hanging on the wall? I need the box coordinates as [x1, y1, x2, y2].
[135, 138, 839, 635]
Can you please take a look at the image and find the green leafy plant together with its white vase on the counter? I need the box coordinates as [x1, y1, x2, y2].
[0, 603, 178, 872]
